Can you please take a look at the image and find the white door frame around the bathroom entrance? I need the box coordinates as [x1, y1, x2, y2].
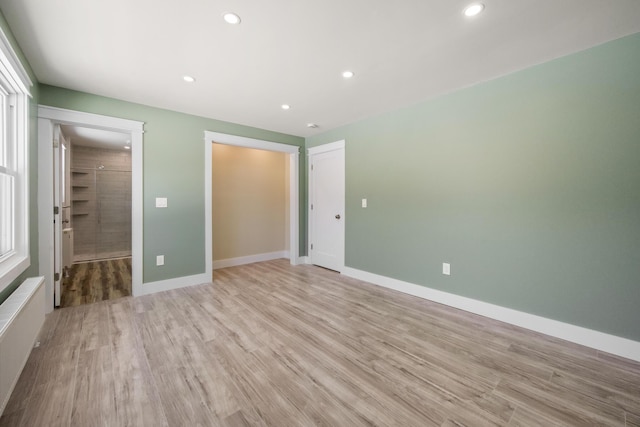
[38, 105, 144, 313]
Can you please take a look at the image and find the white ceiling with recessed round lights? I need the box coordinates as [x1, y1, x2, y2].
[0, 0, 640, 136]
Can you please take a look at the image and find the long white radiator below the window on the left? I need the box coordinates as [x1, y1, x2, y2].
[0, 277, 45, 415]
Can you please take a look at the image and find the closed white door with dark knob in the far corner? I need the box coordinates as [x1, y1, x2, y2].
[309, 141, 345, 271]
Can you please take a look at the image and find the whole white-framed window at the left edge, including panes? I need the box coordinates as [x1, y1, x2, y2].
[0, 30, 31, 291]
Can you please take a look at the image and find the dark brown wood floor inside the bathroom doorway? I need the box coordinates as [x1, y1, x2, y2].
[60, 258, 131, 307]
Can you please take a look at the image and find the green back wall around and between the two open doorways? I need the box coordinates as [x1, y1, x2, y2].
[40, 84, 306, 283]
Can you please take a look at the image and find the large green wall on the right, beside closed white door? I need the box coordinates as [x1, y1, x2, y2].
[306, 34, 640, 341]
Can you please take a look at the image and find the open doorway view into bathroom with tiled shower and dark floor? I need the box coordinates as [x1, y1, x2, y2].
[60, 125, 132, 307]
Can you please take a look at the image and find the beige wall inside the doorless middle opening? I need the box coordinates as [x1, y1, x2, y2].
[212, 144, 288, 261]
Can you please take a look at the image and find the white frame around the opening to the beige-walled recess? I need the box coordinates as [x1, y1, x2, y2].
[204, 131, 300, 278]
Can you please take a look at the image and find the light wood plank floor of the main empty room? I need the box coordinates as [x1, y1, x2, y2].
[0, 260, 640, 427]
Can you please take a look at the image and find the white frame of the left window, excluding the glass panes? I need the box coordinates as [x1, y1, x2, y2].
[0, 28, 33, 292]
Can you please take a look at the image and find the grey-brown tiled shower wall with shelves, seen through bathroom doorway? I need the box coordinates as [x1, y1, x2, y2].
[70, 145, 131, 262]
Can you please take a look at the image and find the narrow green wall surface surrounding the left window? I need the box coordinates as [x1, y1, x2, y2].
[0, 12, 39, 304]
